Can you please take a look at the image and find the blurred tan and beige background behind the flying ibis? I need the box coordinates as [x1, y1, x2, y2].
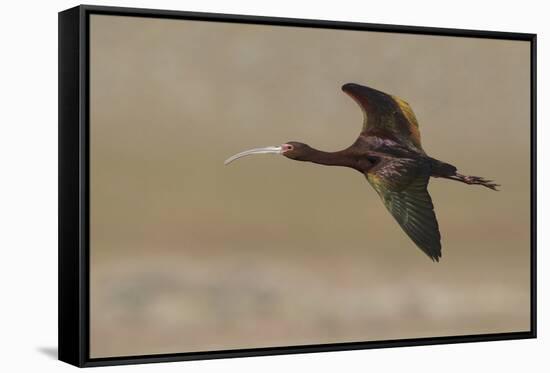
[90, 15, 530, 357]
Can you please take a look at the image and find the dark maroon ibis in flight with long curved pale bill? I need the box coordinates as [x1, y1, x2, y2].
[225, 83, 498, 261]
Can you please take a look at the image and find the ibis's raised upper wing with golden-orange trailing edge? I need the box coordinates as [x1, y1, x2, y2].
[342, 83, 424, 153]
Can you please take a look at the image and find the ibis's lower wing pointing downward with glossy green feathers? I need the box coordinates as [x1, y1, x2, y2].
[366, 158, 441, 261]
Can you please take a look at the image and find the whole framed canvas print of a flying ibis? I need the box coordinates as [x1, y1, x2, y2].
[59, 6, 536, 367]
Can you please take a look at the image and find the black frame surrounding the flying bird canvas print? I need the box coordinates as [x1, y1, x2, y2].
[58, 5, 537, 367]
